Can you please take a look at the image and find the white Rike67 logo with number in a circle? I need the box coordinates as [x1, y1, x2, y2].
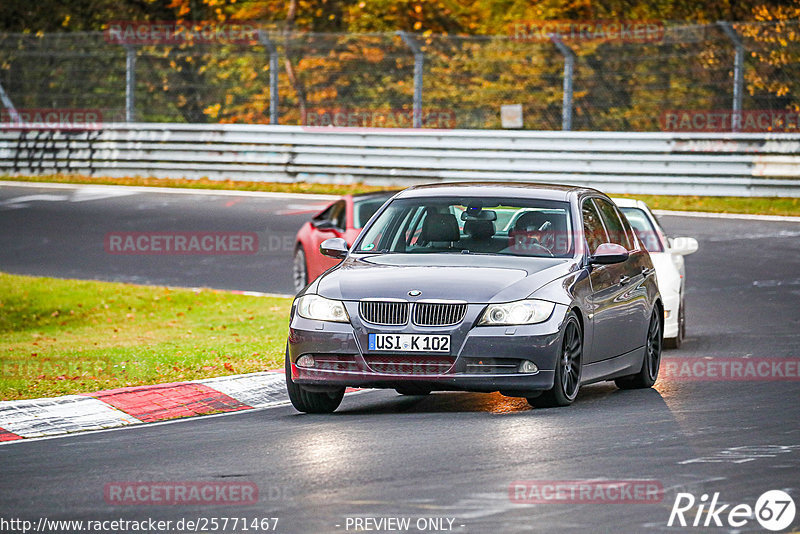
[667, 490, 795, 532]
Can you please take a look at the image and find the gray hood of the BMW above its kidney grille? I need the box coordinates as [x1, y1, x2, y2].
[316, 254, 575, 303]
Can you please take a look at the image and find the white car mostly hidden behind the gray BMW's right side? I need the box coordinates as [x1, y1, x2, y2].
[612, 198, 697, 349]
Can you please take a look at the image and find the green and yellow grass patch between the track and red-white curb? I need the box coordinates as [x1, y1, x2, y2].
[0, 273, 291, 400]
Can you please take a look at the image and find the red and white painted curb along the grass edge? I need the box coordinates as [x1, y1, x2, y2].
[0, 371, 289, 442]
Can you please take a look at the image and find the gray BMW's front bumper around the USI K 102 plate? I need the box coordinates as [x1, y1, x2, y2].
[287, 305, 566, 395]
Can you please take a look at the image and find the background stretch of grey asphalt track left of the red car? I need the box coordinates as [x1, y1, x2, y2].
[0, 187, 328, 294]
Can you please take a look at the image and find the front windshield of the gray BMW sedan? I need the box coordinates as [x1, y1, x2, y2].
[354, 197, 573, 257]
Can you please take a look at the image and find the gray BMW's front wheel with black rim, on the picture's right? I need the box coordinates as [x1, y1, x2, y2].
[527, 312, 583, 408]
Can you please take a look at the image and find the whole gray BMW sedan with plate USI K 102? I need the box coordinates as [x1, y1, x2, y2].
[286, 183, 664, 413]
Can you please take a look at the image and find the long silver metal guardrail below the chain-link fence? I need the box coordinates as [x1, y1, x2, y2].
[0, 123, 800, 197]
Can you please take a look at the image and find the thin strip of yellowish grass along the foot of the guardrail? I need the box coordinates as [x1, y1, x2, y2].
[0, 175, 800, 217]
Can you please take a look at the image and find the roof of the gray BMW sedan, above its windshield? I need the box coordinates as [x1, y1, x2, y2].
[397, 182, 599, 201]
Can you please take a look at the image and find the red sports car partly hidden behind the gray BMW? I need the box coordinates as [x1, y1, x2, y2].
[292, 191, 397, 291]
